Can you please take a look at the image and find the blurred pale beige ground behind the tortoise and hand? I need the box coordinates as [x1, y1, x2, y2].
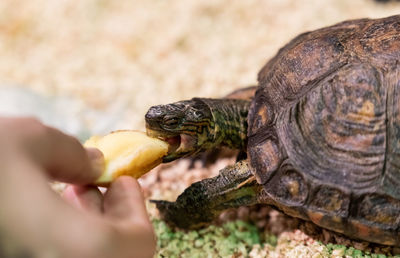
[0, 0, 400, 140]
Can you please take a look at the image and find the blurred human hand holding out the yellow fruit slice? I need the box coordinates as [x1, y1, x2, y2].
[0, 118, 155, 258]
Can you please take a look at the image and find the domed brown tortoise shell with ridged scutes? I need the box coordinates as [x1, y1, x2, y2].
[248, 16, 400, 245]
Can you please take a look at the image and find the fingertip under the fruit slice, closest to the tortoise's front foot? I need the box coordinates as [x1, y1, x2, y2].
[103, 176, 150, 223]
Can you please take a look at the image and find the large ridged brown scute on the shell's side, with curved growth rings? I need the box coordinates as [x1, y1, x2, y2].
[278, 64, 386, 190]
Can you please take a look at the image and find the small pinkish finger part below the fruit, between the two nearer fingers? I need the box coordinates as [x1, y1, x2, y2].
[62, 185, 103, 214]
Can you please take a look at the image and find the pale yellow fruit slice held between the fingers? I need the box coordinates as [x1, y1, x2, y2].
[84, 131, 169, 185]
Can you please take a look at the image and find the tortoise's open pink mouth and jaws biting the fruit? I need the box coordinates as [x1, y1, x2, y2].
[146, 128, 197, 162]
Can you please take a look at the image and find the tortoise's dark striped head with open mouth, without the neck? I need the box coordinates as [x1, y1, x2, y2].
[145, 98, 214, 162]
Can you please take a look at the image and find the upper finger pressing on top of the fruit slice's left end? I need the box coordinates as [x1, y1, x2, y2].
[9, 118, 104, 184]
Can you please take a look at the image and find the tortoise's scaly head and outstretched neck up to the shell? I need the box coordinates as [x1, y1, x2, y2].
[145, 98, 250, 162]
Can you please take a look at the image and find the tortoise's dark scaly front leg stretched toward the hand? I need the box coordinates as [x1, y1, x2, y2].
[152, 161, 262, 228]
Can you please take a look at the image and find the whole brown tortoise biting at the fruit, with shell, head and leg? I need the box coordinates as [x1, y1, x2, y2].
[145, 15, 400, 246]
